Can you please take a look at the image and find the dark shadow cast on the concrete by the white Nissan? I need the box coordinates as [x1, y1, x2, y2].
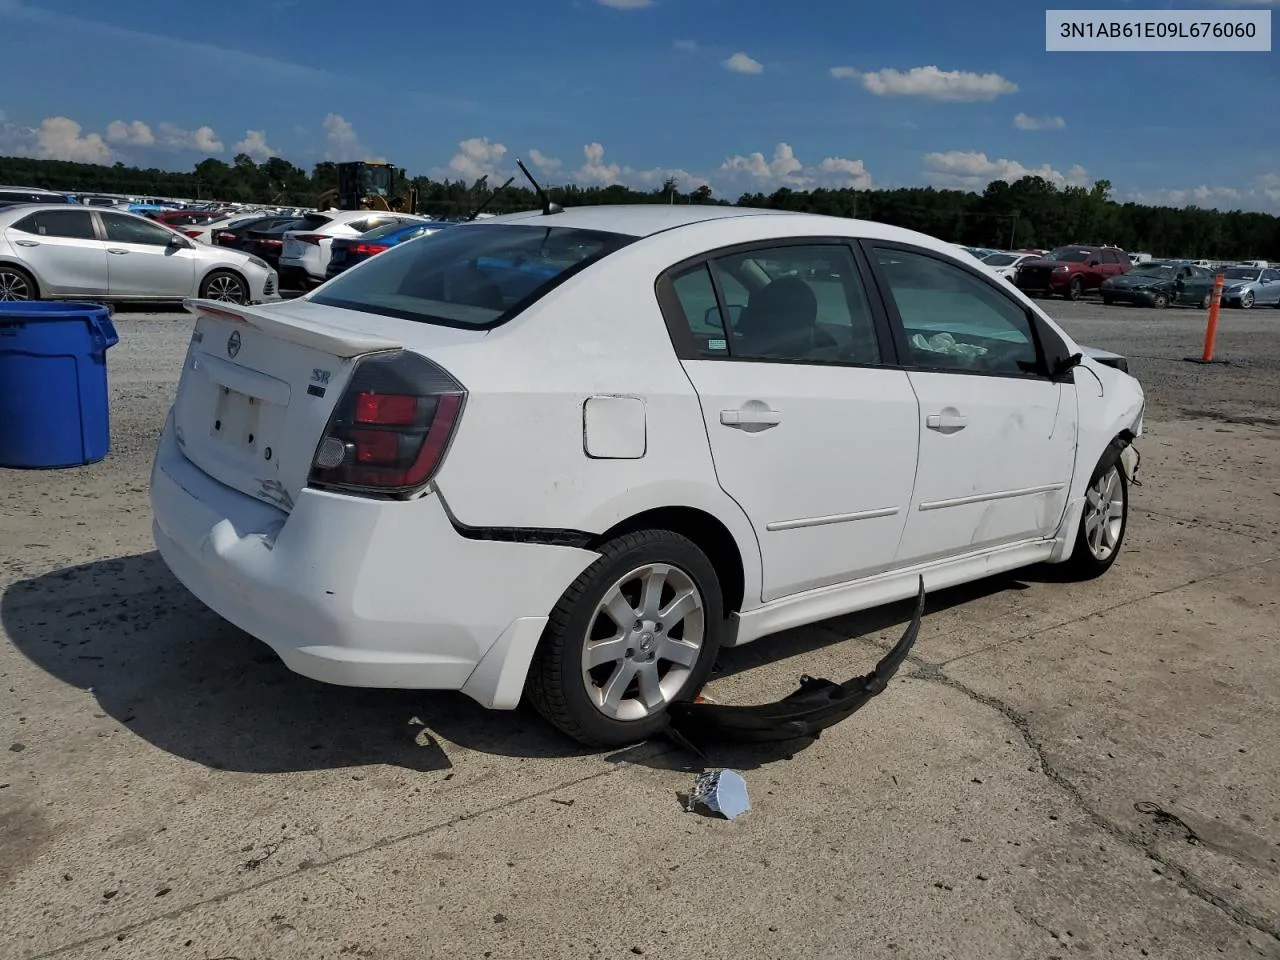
[0, 552, 1052, 773]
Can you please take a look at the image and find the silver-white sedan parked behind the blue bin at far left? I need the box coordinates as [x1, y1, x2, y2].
[0, 204, 279, 303]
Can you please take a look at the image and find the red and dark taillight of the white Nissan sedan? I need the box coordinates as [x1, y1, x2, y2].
[307, 353, 467, 495]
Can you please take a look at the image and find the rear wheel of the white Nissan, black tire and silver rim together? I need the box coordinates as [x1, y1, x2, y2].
[525, 530, 727, 746]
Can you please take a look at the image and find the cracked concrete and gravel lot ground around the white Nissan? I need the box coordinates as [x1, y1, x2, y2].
[0, 301, 1280, 960]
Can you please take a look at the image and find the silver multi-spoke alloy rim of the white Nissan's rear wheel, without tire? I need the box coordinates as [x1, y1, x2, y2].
[582, 563, 707, 721]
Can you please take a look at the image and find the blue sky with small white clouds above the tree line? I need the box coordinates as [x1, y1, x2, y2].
[0, 0, 1280, 212]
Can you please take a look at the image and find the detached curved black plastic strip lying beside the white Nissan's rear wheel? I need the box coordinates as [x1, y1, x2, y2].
[667, 576, 924, 753]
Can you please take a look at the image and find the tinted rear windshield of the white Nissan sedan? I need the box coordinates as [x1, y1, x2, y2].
[311, 224, 635, 328]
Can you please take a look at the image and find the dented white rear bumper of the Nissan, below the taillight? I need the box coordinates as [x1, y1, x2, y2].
[151, 414, 596, 709]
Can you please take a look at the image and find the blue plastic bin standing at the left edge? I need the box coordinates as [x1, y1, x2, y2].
[0, 301, 120, 468]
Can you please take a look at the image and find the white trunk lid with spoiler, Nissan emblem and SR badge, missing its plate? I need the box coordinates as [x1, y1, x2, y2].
[174, 300, 483, 511]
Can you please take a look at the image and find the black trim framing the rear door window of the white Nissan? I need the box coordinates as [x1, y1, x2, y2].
[654, 236, 906, 370]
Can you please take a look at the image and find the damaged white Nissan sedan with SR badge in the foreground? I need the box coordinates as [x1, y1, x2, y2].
[151, 205, 1143, 745]
